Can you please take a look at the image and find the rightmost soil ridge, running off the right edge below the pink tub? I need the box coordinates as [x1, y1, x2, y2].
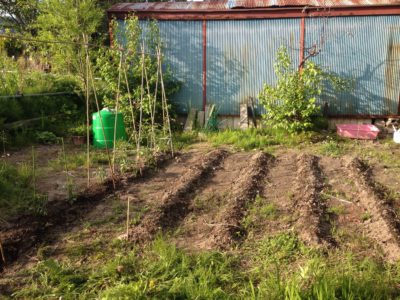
[348, 158, 400, 260]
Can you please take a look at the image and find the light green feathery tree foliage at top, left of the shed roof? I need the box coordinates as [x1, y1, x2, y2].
[35, 0, 103, 77]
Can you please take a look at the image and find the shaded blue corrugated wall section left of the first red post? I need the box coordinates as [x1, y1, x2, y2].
[140, 21, 203, 113]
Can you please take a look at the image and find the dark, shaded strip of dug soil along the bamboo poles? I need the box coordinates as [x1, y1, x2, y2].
[0, 155, 169, 272]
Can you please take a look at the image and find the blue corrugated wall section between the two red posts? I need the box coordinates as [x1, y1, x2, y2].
[207, 19, 300, 115]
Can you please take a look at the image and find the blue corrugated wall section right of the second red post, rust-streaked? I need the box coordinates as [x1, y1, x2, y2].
[305, 16, 400, 115]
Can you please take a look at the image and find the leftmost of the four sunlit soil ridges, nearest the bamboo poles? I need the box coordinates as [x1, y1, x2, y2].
[129, 149, 228, 243]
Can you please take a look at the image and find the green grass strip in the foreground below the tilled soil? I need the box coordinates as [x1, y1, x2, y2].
[14, 233, 400, 299]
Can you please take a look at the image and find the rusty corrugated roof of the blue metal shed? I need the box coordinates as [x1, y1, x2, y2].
[108, 0, 400, 12]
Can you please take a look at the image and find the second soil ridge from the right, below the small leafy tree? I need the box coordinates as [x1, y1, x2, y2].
[293, 154, 335, 246]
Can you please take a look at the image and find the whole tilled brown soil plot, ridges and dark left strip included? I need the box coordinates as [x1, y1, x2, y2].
[0, 147, 400, 294]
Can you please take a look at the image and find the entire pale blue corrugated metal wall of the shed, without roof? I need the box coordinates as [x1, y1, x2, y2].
[126, 16, 400, 115]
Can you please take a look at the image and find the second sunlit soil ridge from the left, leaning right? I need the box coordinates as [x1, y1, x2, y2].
[212, 152, 272, 248]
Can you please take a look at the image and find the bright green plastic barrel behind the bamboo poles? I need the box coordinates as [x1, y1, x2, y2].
[92, 108, 127, 148]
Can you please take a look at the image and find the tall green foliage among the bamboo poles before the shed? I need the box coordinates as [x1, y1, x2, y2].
[96, 16, 179, 143]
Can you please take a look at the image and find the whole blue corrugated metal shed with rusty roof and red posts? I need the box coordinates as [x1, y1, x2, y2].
[108, 0, 400, 119]
